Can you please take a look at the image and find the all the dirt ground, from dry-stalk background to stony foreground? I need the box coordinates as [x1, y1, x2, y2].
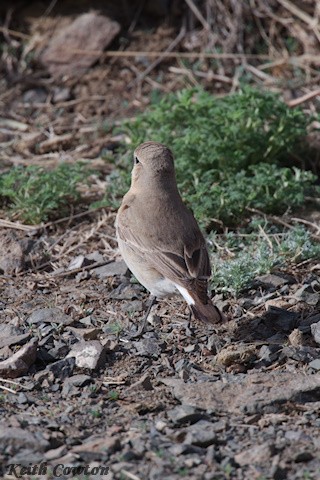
[0, 0, 320, 480]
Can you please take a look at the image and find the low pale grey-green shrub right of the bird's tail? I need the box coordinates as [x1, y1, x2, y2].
[209, 221, 320, 296]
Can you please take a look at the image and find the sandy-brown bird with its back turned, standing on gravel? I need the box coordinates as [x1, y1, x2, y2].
[115, 141, 226, 324]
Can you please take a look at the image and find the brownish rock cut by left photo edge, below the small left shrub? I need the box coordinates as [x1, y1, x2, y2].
[0, 231, 24, 275]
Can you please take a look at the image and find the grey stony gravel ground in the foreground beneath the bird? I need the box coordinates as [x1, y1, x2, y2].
[0, 218, 320, 480]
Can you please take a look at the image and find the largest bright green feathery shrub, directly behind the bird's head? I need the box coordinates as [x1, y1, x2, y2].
[108, 88, 316, 229]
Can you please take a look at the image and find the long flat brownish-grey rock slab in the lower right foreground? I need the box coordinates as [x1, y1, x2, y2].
[163, 371, 320, 414]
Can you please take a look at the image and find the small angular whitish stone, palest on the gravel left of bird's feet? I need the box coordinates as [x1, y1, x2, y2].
[67, 340, 106, 370]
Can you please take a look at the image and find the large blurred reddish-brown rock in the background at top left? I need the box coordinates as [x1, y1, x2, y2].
[40, 12, 120, 77]
